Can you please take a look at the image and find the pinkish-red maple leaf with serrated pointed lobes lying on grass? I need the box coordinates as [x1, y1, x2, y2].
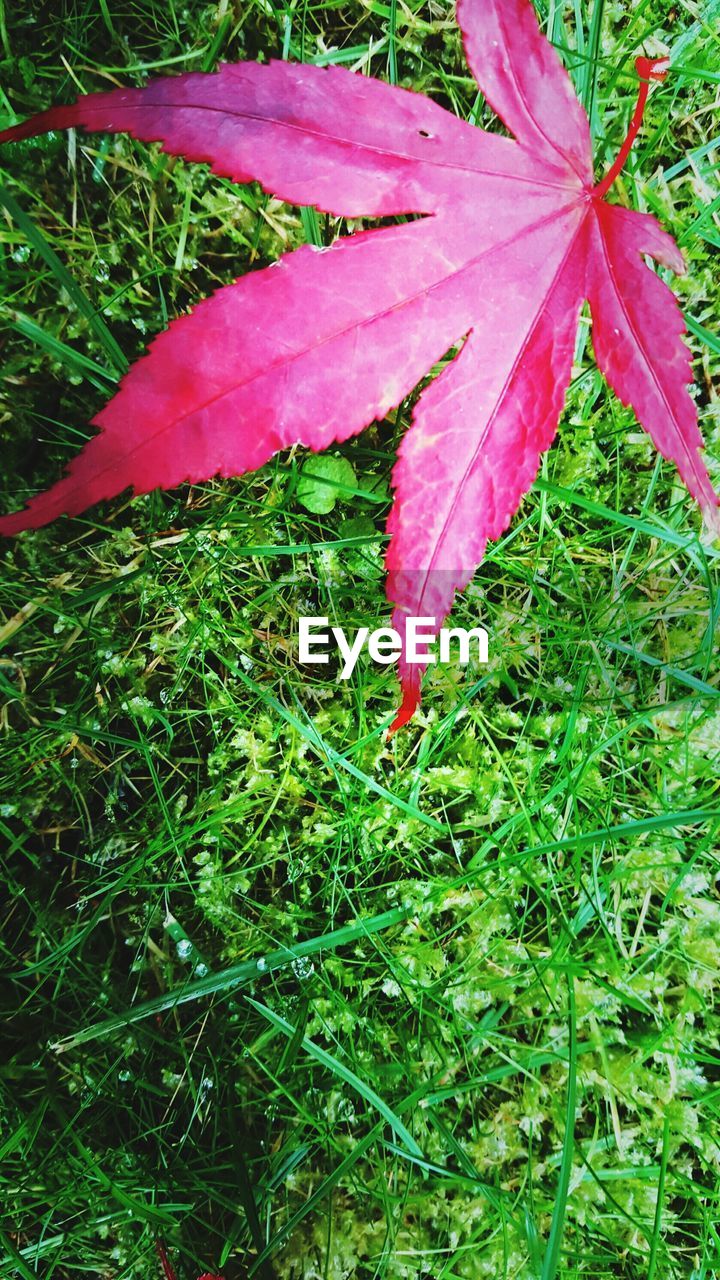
[0, 0, 720, 728]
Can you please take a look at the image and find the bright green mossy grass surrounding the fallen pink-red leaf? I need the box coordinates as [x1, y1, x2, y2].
[0, 0, 720, 1280]
